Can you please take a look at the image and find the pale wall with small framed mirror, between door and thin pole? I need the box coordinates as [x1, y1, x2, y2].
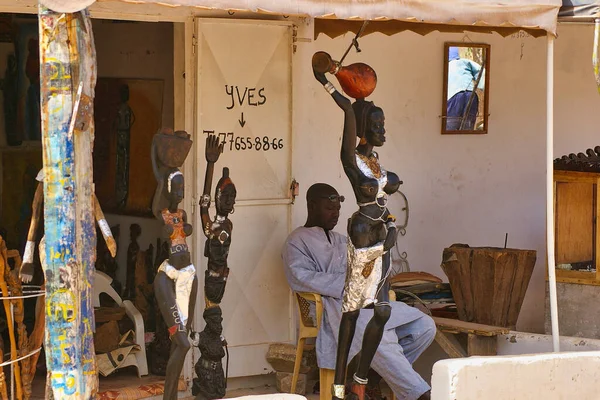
[293, 21, 561, 332]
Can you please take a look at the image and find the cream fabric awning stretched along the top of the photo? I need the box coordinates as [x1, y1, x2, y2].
[41, 0, 562, 35]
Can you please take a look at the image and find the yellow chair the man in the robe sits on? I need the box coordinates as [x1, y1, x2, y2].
[290, 292, 335, 400]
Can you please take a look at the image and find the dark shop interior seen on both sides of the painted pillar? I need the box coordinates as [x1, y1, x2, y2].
[0, 14, 174, 398]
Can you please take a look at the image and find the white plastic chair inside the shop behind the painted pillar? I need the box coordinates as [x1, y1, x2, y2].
[94, 271, 148, 377]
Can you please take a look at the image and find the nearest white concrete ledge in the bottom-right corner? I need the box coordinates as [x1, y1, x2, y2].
[431, 351, 600, 400]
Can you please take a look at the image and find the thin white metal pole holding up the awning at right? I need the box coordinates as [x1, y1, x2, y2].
[546, 35, 560, 352]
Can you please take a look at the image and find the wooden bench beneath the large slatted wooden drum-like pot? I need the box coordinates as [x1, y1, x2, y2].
[433, 317, 510, 358]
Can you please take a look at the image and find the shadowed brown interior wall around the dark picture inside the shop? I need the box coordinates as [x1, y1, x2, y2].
[93, 20, 174, 288]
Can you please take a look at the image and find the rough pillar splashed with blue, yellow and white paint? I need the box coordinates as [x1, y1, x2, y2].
[39, 5, 98, 400]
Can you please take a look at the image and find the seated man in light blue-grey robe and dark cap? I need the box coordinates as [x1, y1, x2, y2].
[282, 183, 436, 400]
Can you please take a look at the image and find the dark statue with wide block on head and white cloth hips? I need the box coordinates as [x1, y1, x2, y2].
[152, 130, 198, 400]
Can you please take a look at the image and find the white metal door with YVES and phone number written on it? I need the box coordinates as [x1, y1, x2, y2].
[195, 19, 293, 377]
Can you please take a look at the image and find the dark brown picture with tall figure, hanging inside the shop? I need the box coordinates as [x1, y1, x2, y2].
[94, 78, 164, 217]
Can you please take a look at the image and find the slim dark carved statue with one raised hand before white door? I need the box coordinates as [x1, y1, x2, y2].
[192, 135, 236, 400]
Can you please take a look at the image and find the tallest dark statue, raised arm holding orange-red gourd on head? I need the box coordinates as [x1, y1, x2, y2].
[313, 52, 401, 400]
